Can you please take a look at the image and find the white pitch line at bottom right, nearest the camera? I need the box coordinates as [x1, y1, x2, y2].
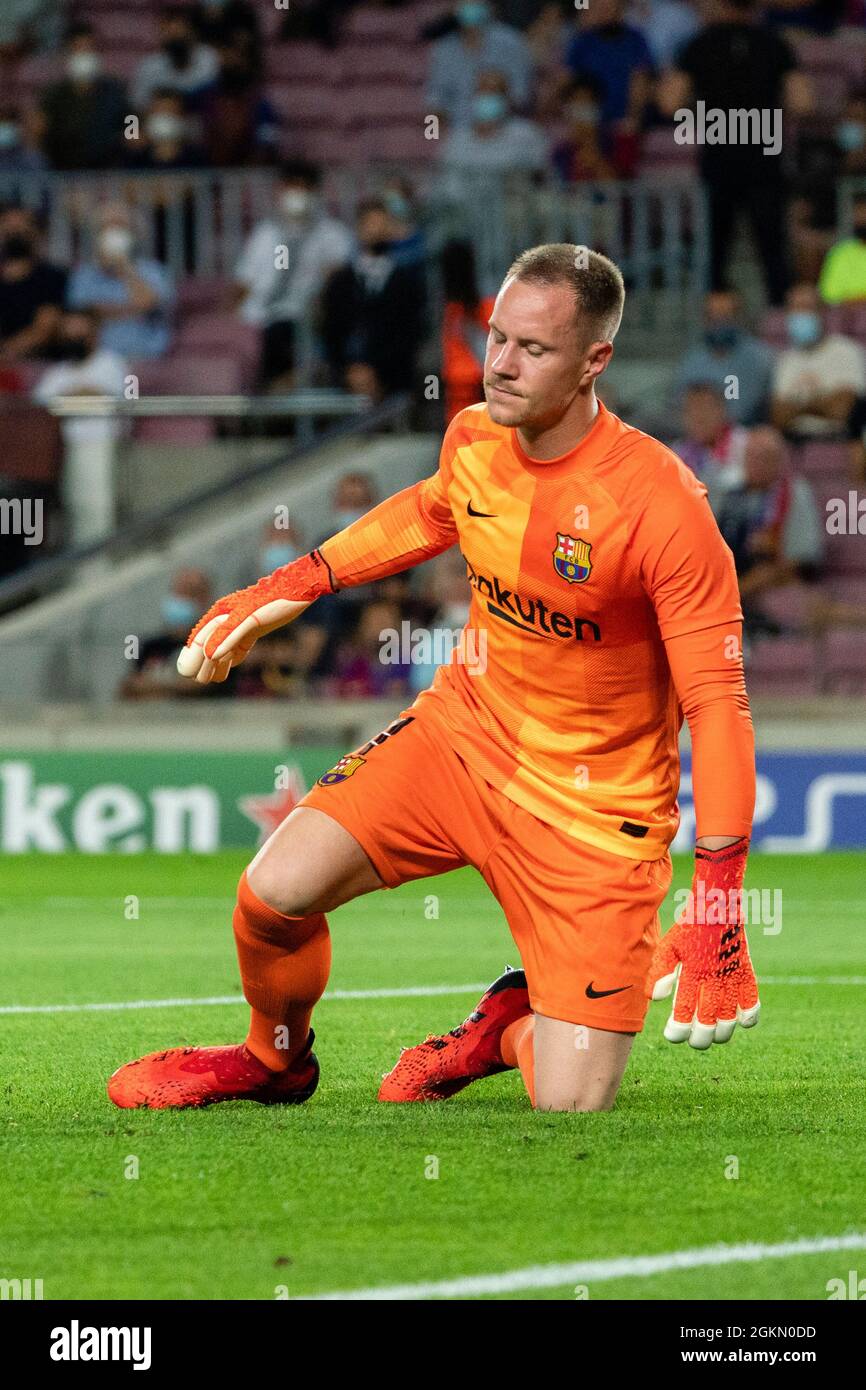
[293, 1232, 866, 1302]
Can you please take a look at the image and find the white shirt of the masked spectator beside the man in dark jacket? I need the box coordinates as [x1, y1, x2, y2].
[235, 214, 354, 328]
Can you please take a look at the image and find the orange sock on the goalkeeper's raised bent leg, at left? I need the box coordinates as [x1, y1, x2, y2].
[232, 872, 331, 1072]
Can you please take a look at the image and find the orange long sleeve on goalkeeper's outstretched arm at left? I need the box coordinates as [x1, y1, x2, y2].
[318, 473, 457, 589]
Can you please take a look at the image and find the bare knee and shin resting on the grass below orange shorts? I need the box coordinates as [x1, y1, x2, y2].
[532, 1013, 634, 1111]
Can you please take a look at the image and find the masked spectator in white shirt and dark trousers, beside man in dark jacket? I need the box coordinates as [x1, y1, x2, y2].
[234, 160, 353, 389]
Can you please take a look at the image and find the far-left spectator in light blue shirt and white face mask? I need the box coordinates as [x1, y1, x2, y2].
[67, 203, 174, 357]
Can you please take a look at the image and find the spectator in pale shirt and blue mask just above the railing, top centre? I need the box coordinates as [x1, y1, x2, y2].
[442, 71, 548, 175]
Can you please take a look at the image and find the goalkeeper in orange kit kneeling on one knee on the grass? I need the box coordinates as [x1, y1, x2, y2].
[108, 243, 759, 1111]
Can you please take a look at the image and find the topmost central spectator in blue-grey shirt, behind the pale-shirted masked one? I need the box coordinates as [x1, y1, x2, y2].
[425, 0, 532, 126]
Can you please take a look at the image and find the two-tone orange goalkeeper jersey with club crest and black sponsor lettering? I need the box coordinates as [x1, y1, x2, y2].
[321, 402, 748, 859]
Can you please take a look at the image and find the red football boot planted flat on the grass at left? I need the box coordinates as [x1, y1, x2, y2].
[108, 1029, 318, 1111]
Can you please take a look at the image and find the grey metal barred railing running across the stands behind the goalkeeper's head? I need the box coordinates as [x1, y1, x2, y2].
[0, 163, 709, 341]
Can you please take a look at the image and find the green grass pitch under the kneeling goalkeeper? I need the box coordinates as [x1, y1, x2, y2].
[0, 853, 866, 1300]
